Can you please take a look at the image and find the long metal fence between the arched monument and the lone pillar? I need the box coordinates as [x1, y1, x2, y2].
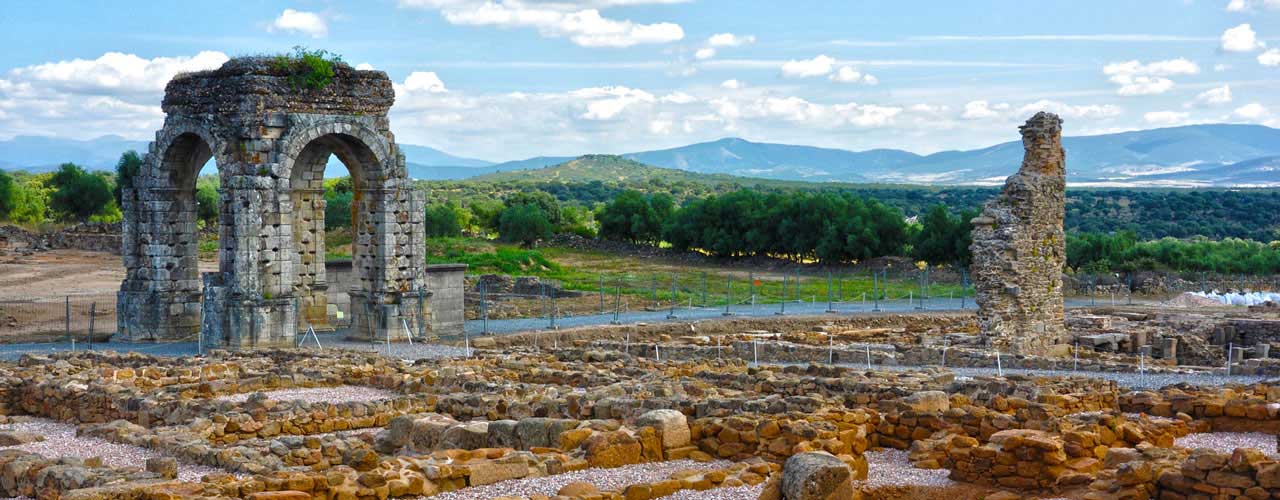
[465, 269, 973, 332]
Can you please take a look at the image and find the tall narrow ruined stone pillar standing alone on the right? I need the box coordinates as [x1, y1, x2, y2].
[969, 111, 1066, 354]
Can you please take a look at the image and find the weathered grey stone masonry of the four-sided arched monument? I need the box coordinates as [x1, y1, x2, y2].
[118, 58, 429, 348]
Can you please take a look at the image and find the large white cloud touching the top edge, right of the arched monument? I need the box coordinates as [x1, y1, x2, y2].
[399, 0, 685, 47]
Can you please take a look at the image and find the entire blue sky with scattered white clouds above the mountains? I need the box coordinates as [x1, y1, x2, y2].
[0, 0, 1280, 161]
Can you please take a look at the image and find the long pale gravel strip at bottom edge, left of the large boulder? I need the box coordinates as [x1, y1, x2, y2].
[431, 460, 730, 500]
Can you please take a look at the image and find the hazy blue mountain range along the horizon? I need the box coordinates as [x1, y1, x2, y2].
[0, 124, 1280, 187]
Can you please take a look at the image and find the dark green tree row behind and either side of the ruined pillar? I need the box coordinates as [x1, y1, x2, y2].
[588, 189, 1280, 274]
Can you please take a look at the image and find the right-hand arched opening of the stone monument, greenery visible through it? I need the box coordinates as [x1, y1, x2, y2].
[289, 133, 380, 330]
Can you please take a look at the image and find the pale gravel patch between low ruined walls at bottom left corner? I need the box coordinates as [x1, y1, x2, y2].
[0, 419, 227, 481]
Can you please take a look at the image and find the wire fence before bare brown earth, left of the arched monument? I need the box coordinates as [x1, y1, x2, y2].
[0, 294, 115, 341]
